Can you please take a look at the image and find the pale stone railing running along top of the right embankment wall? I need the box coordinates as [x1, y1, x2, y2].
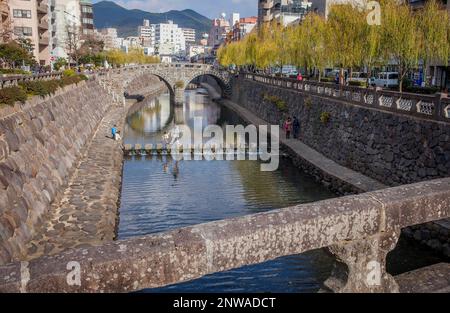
[243, 73, 450, 122]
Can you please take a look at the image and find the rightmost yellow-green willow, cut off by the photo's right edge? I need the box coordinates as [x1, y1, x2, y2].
[418, 0, 450, 85]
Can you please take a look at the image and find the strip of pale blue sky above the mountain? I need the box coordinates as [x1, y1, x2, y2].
[93, 0, 258, 18]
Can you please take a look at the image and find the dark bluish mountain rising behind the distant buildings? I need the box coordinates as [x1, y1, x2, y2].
[93, 1, 211, 39]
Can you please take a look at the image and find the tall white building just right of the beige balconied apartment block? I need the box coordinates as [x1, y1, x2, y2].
[50, 0, 83, 60]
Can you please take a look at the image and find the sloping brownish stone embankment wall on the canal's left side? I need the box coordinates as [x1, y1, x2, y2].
[0, 81, 113, 264]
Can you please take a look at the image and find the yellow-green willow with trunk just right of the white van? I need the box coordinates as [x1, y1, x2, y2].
[381, 0, 423, 92]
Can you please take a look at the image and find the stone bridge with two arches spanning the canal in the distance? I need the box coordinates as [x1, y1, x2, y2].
[102, 63, 231, 104]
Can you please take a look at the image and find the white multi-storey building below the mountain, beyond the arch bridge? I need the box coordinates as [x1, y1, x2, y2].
[154, 21, 186, 55]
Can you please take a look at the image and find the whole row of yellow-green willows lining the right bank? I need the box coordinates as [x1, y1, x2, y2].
[218, 0, 450, 91]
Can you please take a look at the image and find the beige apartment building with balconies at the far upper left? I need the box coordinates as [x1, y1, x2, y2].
[9, 0, 50, 65]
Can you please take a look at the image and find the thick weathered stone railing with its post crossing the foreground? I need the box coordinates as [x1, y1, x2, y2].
[0, 178, 450, 292]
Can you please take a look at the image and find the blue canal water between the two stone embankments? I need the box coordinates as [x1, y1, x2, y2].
[118, 91, 446, 293]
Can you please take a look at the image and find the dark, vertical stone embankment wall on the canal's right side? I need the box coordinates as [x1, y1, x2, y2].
[232, 77, 450, 186]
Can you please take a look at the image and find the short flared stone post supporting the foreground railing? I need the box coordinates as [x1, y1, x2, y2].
[325, 229, 400, 293]
